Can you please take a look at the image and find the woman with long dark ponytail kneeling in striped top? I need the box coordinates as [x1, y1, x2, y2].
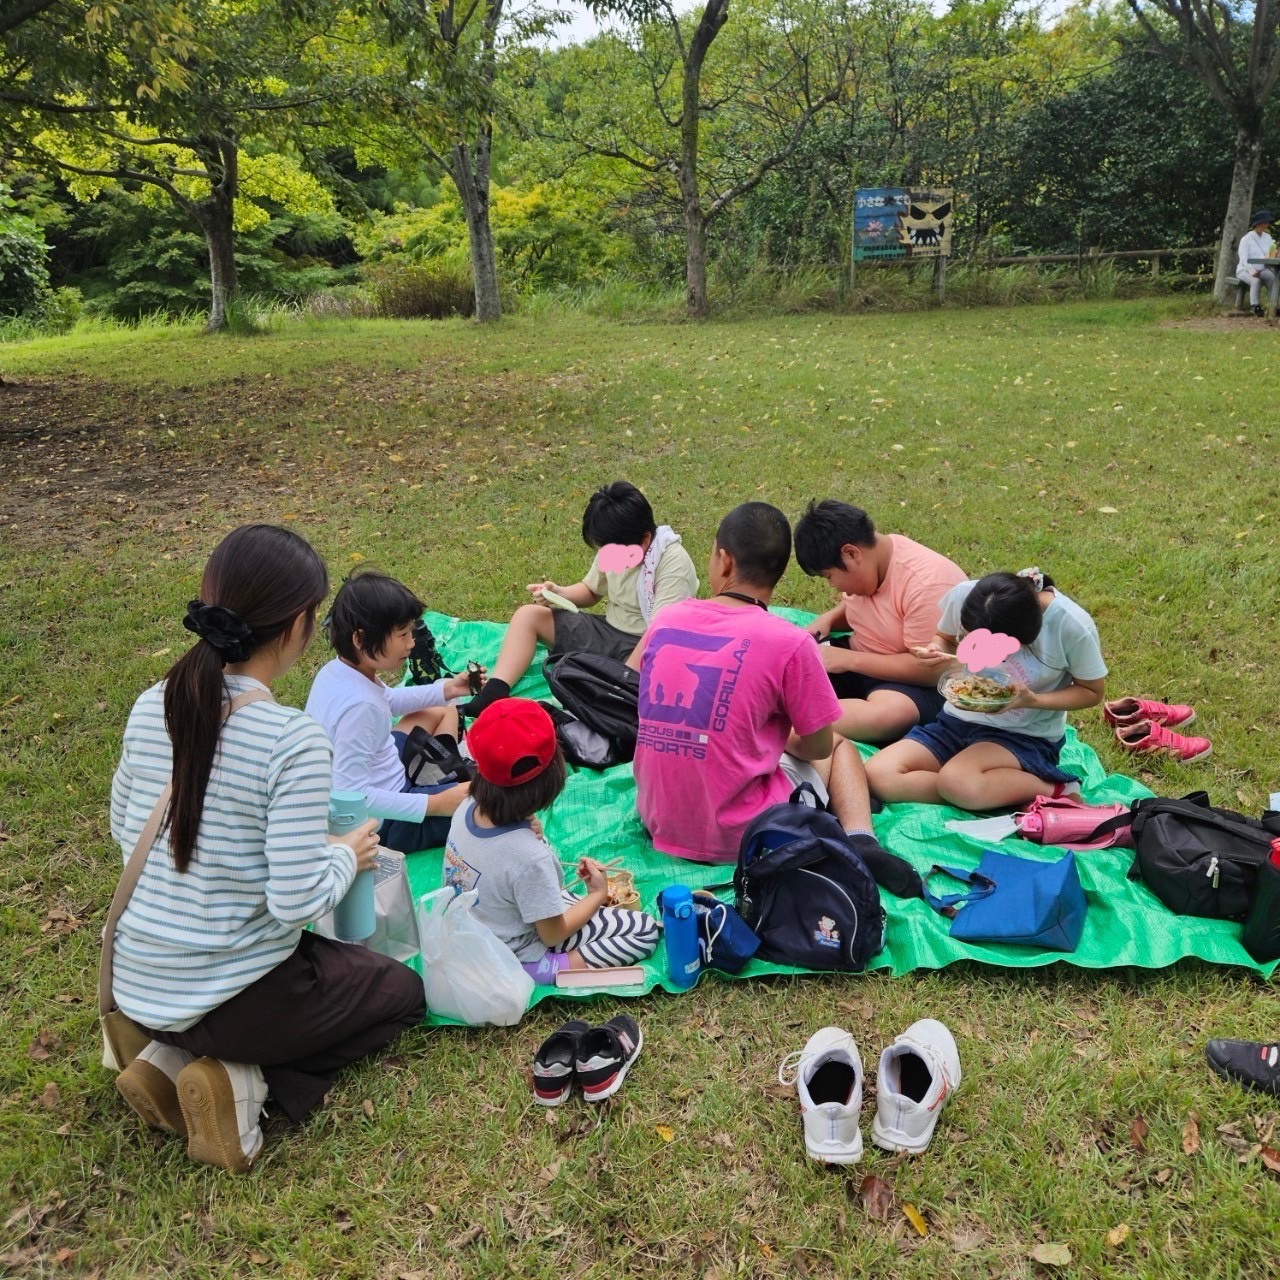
[104, 525, 424, 1171]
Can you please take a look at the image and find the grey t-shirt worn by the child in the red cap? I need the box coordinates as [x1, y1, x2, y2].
[440, 800, 564, 963]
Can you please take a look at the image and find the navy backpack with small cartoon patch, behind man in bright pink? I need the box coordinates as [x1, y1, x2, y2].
[733, 788, 884, 973]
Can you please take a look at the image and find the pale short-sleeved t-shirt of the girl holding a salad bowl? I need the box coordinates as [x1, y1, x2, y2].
[938, 582, 1107, 742]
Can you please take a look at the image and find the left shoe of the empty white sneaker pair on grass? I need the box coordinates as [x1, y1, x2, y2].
[778, 1027, 863, 1165]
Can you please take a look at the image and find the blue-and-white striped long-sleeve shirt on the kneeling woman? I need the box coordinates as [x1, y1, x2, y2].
[111, 676, 356, 1030]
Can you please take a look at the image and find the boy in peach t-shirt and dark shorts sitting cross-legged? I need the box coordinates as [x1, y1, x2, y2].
[796, 499, 966, 742]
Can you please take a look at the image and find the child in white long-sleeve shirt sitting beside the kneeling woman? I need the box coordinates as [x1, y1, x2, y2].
[306, 570, 470, 854]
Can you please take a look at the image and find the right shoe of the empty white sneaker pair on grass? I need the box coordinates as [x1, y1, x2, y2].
[872, 1018, 960, 1153]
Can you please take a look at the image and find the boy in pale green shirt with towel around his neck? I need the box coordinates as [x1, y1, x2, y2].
[461, 480, 698, 717]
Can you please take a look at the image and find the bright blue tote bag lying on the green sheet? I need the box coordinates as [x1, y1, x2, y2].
[924, 849, 1085, 951]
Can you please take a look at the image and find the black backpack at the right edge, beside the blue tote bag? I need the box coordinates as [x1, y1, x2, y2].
[1121, 791, 1280, 920]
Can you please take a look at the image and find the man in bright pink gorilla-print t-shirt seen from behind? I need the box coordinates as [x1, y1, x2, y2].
[635, 502, 879, 863]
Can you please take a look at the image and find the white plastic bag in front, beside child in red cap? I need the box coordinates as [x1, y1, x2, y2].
[417, 888, 534, 1027]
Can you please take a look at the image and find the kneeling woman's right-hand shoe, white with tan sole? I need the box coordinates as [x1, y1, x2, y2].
[178, 1057, 266, 1174]
